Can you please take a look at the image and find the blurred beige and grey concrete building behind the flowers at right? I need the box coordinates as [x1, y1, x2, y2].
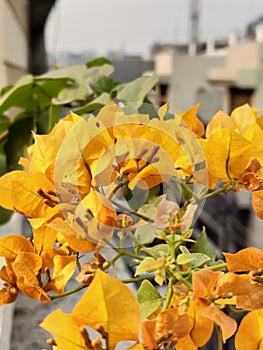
[152, 17, 263, 122]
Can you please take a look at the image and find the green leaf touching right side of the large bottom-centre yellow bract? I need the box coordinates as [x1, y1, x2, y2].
[137, 280, 163, 318]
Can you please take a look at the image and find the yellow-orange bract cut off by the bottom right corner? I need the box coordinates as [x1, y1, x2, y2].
[235, 309, 263, 350]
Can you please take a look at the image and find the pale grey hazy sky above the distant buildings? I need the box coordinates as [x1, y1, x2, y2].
[46, 0, 263, 57]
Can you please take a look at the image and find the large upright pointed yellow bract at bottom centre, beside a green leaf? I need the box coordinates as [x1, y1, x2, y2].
[72, 270, 141, 350]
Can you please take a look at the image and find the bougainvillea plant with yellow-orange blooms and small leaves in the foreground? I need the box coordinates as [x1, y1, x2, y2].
[0, 95, 263, 350]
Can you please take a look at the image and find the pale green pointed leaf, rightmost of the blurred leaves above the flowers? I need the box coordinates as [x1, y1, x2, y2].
[117, 75, 159, 102]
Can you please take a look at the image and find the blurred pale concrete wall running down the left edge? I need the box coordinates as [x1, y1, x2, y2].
[0, 0, 29, 350]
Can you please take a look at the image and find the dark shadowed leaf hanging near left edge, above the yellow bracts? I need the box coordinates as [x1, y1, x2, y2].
[4, 113, 35, 171]
